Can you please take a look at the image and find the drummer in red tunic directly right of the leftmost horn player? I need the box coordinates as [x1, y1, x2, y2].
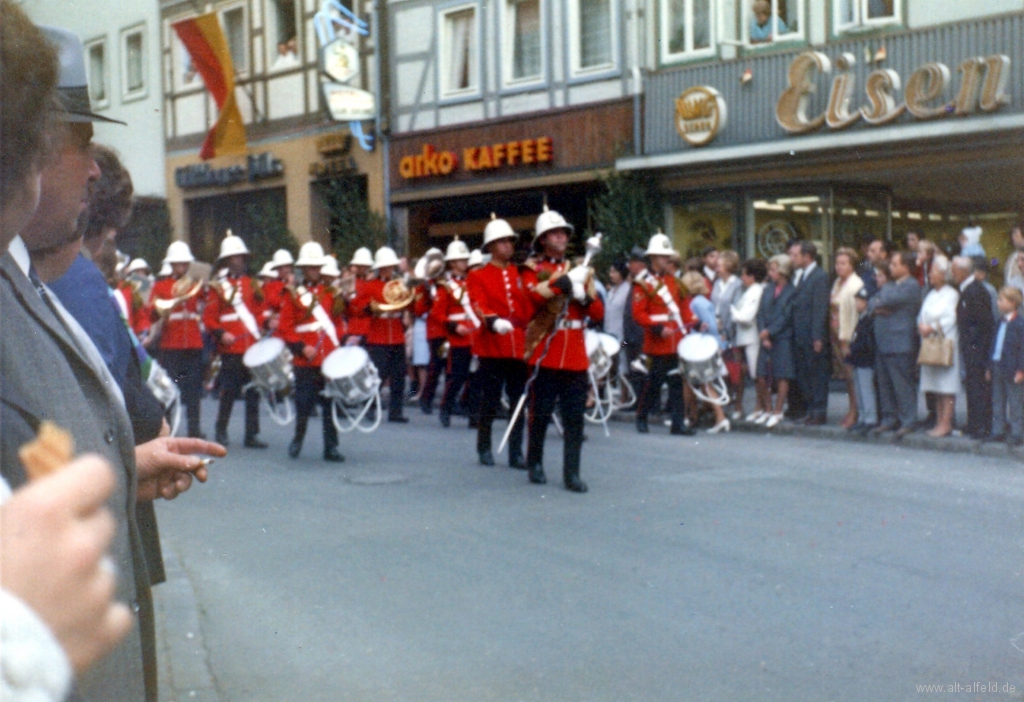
[203, 230, 266, 448]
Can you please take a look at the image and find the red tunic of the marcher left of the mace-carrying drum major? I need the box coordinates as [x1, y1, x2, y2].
[466, 261, 534, 360]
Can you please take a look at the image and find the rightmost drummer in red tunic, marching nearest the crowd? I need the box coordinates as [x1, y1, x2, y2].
[633, 232, 694, 436]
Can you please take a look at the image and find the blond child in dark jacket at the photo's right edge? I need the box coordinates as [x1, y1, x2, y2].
[985, 286, 1024, 446]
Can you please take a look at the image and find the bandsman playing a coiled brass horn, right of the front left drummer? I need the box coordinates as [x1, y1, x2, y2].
[352, 247, 414, 424]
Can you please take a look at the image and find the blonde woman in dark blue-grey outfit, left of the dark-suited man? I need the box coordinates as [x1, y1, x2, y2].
[757, 254, 797, 429]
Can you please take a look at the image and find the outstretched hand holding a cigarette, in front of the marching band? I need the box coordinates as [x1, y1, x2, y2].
[135, 437, 227, 502]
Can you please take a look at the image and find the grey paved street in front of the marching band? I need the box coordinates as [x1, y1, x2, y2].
[157, 404, 1024, 702]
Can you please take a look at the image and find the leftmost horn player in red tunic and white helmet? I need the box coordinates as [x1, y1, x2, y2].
[150, 242, 206, 439]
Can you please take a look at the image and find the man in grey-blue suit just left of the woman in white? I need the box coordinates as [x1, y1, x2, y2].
[867, 252, 921, 439]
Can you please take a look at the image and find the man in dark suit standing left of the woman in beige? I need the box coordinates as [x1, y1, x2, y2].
[790, 242, 831, 426]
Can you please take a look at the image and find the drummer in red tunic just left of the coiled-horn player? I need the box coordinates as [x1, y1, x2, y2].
[278, 242, 345, 463]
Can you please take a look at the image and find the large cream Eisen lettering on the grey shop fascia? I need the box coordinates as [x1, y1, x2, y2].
[775, 51, 1010, 134]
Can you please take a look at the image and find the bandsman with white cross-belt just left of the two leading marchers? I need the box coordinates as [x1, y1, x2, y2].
[427, 238, 480, 427]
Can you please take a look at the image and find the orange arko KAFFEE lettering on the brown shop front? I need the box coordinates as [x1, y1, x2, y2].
[398, 136, 555, 180]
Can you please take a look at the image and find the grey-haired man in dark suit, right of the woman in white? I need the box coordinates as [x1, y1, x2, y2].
[952, 256, 995, 439]
